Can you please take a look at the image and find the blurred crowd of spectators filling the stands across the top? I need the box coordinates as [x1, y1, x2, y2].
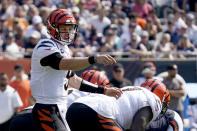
[0, 0, 197, 59]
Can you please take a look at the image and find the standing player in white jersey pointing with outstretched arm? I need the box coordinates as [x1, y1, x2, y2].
[31, 9, 122, 131]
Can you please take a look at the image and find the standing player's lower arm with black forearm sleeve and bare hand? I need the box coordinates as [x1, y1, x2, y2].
[67, 73, 122, 99]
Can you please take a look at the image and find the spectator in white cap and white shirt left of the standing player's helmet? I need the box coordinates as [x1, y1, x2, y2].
[26, 15, 50, 38]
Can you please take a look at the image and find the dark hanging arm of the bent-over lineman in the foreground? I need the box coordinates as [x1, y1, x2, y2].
[130, 106, 153, 131]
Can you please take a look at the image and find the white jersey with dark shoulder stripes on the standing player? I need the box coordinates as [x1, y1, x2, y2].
[31, 39, 70, 104]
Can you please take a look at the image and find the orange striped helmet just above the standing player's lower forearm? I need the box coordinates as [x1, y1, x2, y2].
[80, 70, 110, 88]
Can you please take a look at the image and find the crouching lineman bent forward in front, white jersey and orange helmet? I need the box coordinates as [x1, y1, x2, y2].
[66, 79, 170, 131]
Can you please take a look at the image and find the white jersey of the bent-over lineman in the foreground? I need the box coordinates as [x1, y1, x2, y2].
[75, 86, 162, 129]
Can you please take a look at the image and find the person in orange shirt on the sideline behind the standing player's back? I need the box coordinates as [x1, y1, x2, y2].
[10, 65, 34, 111]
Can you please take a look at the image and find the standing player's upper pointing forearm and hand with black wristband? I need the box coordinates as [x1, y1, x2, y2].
[59, 55, 116, 70]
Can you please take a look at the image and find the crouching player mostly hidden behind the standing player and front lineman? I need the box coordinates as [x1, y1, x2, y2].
[10, 70, 110, 131]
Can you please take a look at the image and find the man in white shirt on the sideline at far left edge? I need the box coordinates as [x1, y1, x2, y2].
[0, 73, 23, 131]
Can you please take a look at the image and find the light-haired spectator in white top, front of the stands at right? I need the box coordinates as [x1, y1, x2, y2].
[156, 33, 174, 59]
